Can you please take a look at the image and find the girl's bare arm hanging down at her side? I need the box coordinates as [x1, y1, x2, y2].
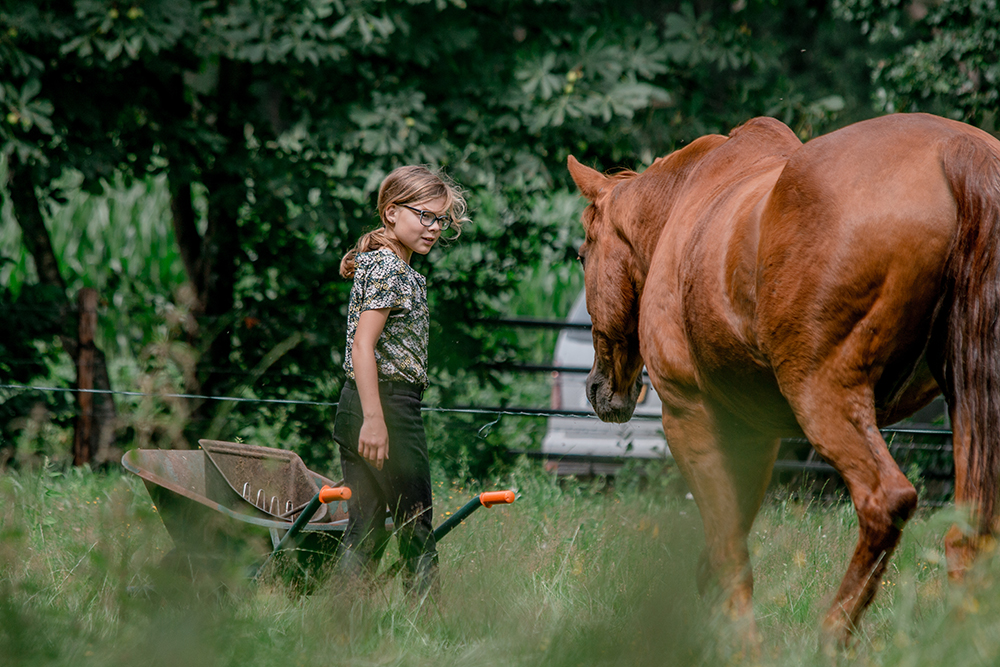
[351, 308, 389, 470]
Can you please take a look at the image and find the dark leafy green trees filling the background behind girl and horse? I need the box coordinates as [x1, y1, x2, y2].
[0, 0, 1000, 477]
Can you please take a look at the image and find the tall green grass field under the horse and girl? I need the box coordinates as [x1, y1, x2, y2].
[0, 463, 1000, 667]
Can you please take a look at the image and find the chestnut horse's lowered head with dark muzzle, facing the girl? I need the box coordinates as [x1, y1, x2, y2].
[568, 155, 642, 422]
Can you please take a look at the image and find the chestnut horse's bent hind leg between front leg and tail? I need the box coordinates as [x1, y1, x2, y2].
[789, 374, 917, 641]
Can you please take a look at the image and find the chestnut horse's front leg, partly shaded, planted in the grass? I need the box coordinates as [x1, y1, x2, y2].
[663, 404, 779, 645]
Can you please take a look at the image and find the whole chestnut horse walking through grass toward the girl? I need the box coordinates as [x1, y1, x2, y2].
[569, 114, 1000, 640]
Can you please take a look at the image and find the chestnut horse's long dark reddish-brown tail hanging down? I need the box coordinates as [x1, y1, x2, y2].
[943, 135, 1000, 534]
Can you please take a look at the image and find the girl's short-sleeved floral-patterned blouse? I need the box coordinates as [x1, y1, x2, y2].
[344, 248, 430, 388]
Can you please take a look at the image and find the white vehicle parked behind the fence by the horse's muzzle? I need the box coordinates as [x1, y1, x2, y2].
[542, 291, 670, 474]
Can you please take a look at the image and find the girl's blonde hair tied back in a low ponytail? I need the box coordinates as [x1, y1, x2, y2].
[340, 164, 469, 278]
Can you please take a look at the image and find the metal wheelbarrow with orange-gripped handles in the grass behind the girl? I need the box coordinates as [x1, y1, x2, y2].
[122, 440, 515, 577]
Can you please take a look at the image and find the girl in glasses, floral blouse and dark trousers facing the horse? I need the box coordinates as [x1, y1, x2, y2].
[334, 165, 467, 595]
